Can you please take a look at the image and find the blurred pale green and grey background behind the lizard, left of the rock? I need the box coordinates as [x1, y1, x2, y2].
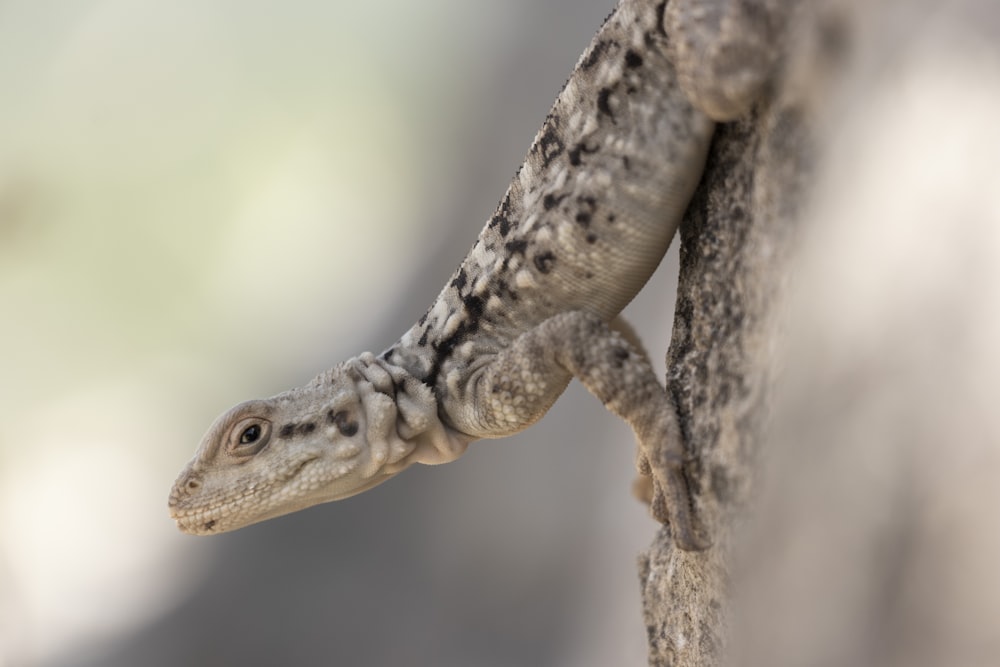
[0, 0, 676, 667]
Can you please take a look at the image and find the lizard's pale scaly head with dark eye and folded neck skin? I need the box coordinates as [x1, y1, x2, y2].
[168, 354, 467, 535]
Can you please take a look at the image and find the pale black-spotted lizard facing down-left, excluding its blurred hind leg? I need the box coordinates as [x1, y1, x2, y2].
[168, 0, 756, 550]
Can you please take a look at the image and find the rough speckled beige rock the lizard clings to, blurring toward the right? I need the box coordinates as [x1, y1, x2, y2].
[640, 0, 1000, 665]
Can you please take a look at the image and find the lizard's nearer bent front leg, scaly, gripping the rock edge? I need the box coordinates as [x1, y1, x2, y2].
[443, 311, 709, 551]
